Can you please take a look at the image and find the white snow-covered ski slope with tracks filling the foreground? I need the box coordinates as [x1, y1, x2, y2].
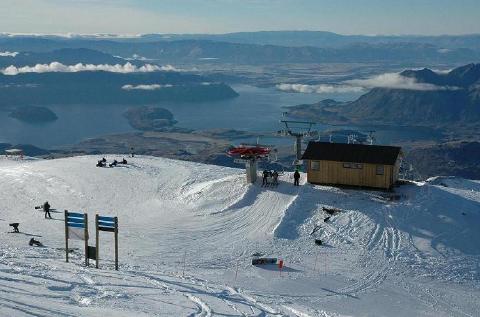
[0, 155, 480, 317]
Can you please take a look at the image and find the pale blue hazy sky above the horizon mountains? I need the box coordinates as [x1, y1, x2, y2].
[0, 0, 480, 35]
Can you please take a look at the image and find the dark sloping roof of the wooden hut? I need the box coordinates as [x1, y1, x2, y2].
[302, 142, 401, 165]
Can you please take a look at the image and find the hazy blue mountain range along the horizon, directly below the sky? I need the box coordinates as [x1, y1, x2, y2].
[0, 32, 480, 64]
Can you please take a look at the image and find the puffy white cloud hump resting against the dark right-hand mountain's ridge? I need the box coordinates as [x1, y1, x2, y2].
[344, 73, 452, 91]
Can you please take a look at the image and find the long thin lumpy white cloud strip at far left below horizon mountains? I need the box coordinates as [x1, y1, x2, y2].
[0, 62, 177, 76]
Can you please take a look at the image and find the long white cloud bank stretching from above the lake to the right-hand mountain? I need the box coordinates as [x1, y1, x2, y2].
[276, 73, 458, 94]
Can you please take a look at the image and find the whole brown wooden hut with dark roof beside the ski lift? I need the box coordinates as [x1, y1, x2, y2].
[302, 142, 402, 189]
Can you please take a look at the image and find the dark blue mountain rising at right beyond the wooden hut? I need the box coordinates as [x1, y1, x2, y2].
[289, 64, 480, 127]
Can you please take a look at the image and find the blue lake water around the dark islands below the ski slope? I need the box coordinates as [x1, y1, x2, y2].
[0, 85, 442, 149]
